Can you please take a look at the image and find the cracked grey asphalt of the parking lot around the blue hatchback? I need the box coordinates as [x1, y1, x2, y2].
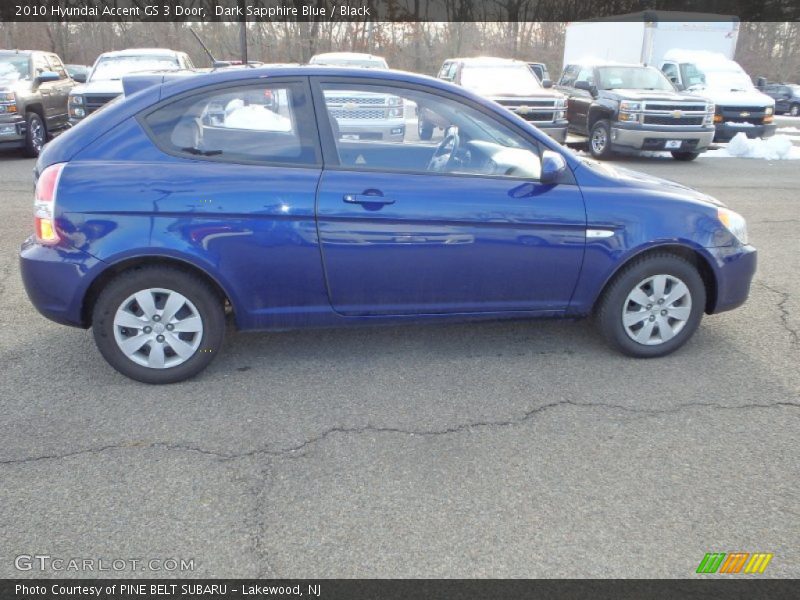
[0, 143, 800, 578]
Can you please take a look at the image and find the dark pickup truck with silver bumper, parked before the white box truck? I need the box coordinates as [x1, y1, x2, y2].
[556, 64, 715, 160]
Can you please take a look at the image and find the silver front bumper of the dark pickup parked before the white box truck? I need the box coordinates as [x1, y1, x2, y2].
[611, 123, 714, 152]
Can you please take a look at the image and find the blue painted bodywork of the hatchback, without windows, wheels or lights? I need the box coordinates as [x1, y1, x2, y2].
[21, 67, 755, 329]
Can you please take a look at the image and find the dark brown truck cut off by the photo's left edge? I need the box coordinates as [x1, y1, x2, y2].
[0, 50, 75, 157]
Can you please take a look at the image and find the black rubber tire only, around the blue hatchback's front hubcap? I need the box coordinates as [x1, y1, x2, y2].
[595, 253, 706, 358]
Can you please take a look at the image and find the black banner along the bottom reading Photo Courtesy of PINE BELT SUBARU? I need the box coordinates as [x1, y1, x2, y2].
[0, 576, 798, 600]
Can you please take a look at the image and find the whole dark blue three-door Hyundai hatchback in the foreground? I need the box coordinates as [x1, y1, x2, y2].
[20, 66, 756, 383]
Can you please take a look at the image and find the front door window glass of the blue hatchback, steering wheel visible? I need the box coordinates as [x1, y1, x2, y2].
[321, 83, 541, 180]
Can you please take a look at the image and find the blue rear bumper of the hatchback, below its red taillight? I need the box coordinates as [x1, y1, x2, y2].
[19, 238, 103, 327]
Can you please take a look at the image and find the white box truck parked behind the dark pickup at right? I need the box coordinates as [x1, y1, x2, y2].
[564, 11, 775, 141]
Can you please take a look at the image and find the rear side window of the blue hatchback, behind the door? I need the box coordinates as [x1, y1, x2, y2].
[143, 83, 320, 166]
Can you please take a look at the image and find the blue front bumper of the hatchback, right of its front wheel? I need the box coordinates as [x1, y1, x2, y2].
[707, 246, 758, 314]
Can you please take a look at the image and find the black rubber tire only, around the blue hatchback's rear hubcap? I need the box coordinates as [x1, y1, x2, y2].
[92, 266, 225, 384]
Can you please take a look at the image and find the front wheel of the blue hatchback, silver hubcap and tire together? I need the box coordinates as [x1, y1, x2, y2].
[597, 254, 706, 358]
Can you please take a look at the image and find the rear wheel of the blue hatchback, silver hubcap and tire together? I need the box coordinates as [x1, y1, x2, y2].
[92, 267, 225, 383]
